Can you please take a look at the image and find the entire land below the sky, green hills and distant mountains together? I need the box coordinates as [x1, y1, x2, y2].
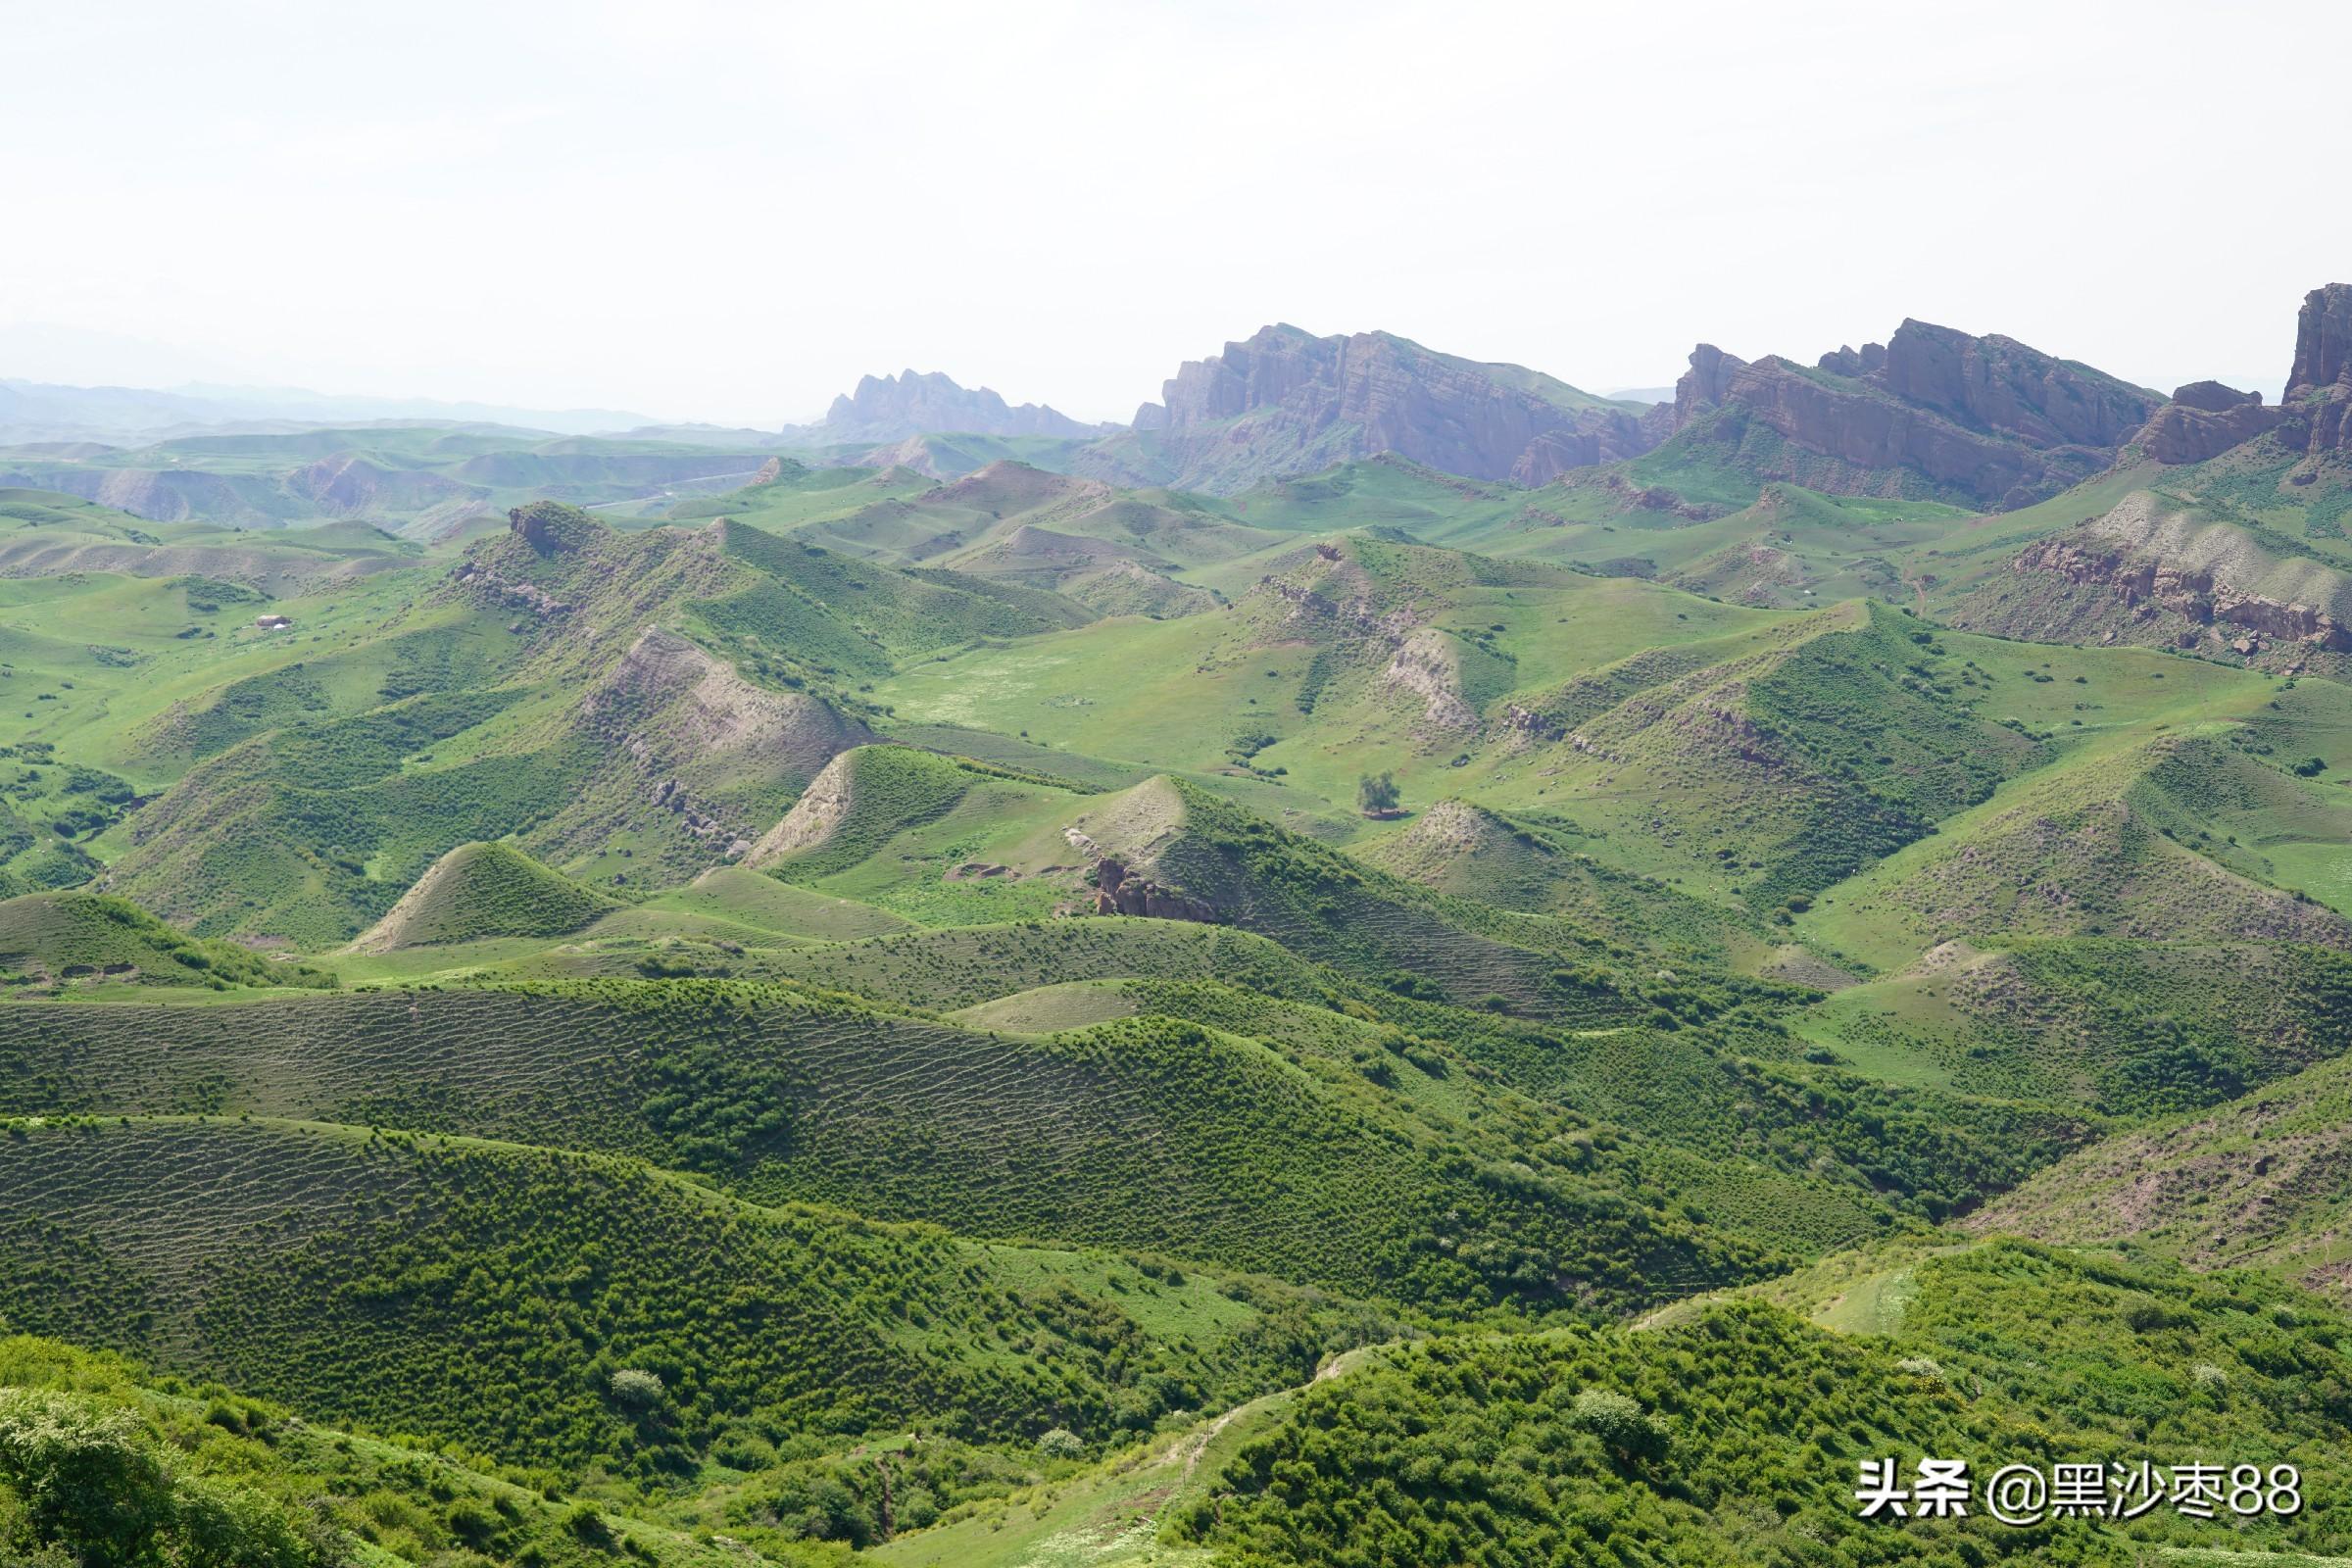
[0, 284, 2352, 1568]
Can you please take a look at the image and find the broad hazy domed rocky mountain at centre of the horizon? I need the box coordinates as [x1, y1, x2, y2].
[1082, 326, 1663, 494]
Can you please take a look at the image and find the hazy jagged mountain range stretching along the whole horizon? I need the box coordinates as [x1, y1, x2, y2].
[23, 284, 2352, 522]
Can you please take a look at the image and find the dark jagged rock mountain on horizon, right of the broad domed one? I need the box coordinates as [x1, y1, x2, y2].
[1675, 322, 2162, 511]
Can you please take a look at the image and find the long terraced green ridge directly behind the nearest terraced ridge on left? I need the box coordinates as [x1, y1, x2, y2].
[0, 983, 1766, 1312]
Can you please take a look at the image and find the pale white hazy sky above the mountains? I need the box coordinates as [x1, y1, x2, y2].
[0, 0, 2352, 425]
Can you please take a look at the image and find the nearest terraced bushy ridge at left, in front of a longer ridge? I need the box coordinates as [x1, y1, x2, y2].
[0, 1121, 1364, 1476]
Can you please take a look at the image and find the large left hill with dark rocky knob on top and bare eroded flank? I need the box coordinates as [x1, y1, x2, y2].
[96, 506, 1124, 948]
